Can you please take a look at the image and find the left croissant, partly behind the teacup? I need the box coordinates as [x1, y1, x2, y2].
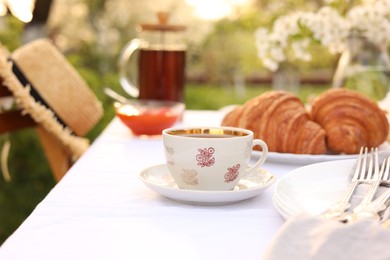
[222, 91, 326, 154]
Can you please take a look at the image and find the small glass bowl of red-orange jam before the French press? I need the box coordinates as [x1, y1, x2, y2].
[114, 100, 185, 136]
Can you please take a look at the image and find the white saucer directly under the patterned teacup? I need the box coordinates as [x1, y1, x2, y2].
[139, 164, 275, 205]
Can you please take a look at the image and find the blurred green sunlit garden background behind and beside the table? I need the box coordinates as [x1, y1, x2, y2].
[0, 0, 357, 244]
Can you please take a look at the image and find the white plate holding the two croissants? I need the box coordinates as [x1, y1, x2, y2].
[255, 142, 390, 166]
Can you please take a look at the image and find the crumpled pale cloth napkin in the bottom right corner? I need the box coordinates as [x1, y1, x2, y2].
[263, 214, 390, 260]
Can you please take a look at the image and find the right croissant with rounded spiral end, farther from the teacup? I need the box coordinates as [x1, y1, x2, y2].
[310, 88, 389, 154]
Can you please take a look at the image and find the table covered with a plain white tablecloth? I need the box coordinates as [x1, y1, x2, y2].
[0, 111, 297, 260]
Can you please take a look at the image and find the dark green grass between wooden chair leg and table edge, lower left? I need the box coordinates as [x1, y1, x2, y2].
[0, 129, 55, 244]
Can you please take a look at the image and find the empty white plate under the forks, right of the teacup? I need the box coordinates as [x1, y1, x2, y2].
[273, 160, 356, 219]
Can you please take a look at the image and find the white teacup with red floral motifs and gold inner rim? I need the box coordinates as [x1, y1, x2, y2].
[163, 127, 268, 190]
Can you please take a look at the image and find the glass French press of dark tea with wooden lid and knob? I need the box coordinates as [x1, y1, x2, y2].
[119, 12, 187, 102]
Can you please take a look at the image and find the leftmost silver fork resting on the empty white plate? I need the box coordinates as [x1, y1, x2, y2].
[320, 147, 377, 218]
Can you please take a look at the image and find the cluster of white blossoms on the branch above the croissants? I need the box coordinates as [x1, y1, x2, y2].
[255, 0, 390, 71]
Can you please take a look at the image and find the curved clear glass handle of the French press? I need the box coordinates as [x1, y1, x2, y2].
[119, 39, 141, 98]
